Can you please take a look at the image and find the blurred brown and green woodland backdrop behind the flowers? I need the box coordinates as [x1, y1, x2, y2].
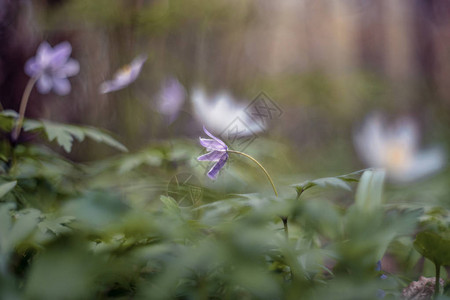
[0, 0, 450, 174]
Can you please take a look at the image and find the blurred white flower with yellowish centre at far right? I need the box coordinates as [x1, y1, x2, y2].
[354, 114, 445, 182]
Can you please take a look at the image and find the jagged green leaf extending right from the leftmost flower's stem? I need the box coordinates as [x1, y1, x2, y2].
[23, 120, 128, 152]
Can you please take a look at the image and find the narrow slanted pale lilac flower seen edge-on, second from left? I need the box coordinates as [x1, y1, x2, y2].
[100, 55, 147, 94]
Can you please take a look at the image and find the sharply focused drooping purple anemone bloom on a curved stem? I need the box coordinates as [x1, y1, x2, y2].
[197, 126, 228, 179]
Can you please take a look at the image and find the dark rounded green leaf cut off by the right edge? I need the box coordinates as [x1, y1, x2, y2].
[414, 231, 450, 266]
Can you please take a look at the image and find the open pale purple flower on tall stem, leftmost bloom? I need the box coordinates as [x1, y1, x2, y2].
[25, 42, 80, 95]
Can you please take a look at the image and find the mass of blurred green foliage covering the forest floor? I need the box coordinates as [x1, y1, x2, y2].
[0, 112, 450, 299]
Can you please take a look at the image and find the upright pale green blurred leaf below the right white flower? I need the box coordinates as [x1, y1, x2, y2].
[355, 170, 385, 212]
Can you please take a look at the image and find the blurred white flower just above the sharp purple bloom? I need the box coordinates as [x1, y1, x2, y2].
[192, 88, 264, 136]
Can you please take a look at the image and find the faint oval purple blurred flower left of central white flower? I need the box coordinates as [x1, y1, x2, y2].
[158, 78, 186, 123]
